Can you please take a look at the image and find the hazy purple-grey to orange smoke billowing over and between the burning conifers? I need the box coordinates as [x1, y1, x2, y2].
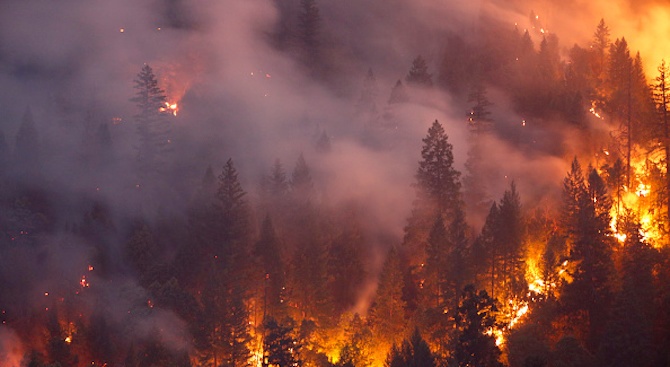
[0, 0, 670, 358]
